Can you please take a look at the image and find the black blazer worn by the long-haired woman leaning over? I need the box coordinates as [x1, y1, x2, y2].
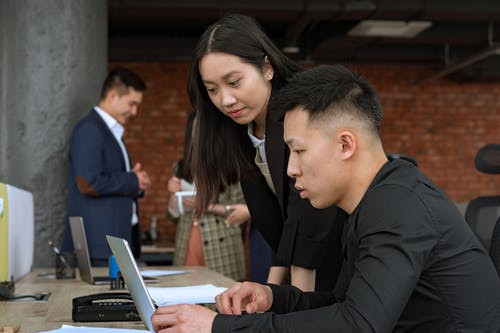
[241, 105, 346, 290]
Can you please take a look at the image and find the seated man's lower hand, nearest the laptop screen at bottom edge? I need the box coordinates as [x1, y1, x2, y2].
[151, 304, 216, 333]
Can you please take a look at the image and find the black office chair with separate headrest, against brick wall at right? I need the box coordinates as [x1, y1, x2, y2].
[465, 144, 500, 251]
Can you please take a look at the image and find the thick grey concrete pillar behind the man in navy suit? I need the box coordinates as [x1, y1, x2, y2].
[0, 0, 107, 267]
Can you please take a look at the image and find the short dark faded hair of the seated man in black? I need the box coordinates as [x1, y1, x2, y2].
[271, 65, 383, 137]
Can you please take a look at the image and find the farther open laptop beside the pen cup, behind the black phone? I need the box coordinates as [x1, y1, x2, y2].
[69, 216, 109, 284]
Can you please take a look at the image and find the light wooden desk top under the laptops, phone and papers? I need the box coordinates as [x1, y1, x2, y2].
[0, 266, 235, 333]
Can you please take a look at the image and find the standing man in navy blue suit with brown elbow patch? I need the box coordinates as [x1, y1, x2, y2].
[62, 67, 151, 266]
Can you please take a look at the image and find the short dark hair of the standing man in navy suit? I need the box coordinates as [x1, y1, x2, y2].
[101, 66, 146, 99]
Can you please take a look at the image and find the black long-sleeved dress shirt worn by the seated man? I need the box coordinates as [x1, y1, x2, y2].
[212, 160, 500, 333]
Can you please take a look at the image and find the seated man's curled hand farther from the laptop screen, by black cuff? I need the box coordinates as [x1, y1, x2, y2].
[215, 282, 273, 315]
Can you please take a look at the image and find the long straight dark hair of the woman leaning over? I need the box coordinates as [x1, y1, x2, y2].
[188, 14, 300, 214]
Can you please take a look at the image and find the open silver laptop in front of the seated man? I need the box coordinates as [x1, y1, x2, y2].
[106, 235, 155, 332]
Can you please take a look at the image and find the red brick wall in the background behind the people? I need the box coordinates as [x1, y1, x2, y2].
[113, 62, 500, 242]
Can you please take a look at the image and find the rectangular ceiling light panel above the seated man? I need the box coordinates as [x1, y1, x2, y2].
[347, 20, 432, 38]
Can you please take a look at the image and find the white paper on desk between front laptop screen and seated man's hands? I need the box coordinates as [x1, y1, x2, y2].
[148, 284, 226, 306]
